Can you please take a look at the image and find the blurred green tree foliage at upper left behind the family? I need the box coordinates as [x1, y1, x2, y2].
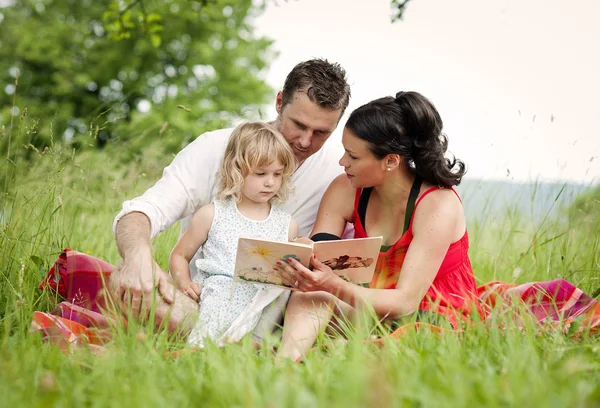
[0, 0, 272, 158]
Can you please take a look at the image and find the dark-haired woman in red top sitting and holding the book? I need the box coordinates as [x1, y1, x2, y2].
[278, 92, 479, 359]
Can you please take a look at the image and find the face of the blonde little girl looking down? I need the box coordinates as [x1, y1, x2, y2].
[241, 160, 283, 203]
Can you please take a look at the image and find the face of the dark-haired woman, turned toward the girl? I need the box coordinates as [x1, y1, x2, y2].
[340, 128, 385, 188]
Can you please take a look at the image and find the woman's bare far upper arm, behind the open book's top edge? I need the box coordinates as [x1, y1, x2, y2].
[310, 174, 356, 237]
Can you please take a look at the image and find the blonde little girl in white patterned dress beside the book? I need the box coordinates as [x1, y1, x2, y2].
[169, 122, 298, 347]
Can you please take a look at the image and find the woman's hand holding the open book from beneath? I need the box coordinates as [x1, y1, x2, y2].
[273, 255, 340, 292]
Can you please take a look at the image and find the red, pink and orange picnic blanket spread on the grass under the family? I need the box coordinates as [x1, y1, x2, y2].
[31, 248, 600, 353]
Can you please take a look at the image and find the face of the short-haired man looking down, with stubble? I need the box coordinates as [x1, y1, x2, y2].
[276, 91, 342, 164]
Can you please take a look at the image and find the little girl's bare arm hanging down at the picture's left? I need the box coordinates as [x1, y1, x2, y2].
[169, 203, 215, 288]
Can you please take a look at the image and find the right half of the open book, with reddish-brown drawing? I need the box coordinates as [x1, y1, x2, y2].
[313, 237, 383, 284]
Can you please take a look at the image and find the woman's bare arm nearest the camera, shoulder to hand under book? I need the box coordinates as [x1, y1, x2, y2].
[286, 190, 464, 319]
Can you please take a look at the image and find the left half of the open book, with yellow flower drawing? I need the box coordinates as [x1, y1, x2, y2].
[234, 238, 312, 289]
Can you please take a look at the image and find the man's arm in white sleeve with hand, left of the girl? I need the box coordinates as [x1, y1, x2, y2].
[111, 129, 230, 317]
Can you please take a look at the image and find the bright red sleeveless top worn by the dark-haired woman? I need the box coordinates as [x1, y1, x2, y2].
[354, 187, 481, 328]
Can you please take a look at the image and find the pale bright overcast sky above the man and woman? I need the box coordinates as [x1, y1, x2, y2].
[255, 0, 600, 183]
